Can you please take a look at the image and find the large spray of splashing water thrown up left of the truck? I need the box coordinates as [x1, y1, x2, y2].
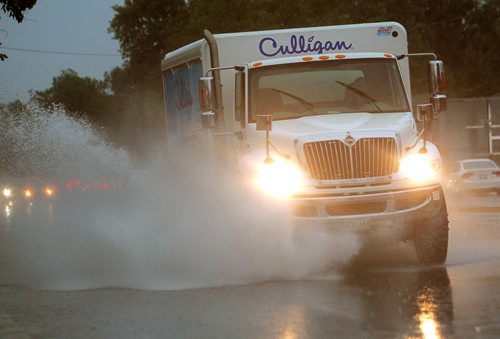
[0, 107, 358, 290]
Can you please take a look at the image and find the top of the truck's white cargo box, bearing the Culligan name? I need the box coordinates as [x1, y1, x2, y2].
[161, 22, 407, 71]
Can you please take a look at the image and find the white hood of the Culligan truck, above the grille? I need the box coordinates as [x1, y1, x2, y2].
[271, 112, 416, 146]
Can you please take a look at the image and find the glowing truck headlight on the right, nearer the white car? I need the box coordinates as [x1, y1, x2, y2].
[399, 153, 441, 181]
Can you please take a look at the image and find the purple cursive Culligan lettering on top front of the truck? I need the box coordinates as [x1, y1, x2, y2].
[259, 35, 352, 57]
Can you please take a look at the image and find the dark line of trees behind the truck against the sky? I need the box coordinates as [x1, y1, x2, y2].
[3, 0, 500, 157]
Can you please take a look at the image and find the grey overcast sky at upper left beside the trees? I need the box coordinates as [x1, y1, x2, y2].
[0, 0, 123, 103]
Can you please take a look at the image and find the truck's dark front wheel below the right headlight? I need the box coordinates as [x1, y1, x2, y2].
[413, 207, 448, 265]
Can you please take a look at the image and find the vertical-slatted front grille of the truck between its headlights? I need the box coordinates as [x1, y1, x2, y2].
[304, 138, 399, 180]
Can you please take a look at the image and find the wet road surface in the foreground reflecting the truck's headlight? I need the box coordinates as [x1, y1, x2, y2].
[0, 195, 500, 338]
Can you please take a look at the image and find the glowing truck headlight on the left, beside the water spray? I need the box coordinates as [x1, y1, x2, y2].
[255, 159, 305, 199]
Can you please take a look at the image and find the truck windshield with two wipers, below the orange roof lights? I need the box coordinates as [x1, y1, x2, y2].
[249, 58, 409, 122]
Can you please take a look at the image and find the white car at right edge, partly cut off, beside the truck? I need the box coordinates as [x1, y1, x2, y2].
[446, 159, 500, 194]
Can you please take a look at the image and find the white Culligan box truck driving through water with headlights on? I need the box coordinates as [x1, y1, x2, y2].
[161, 22, 448, 264]
